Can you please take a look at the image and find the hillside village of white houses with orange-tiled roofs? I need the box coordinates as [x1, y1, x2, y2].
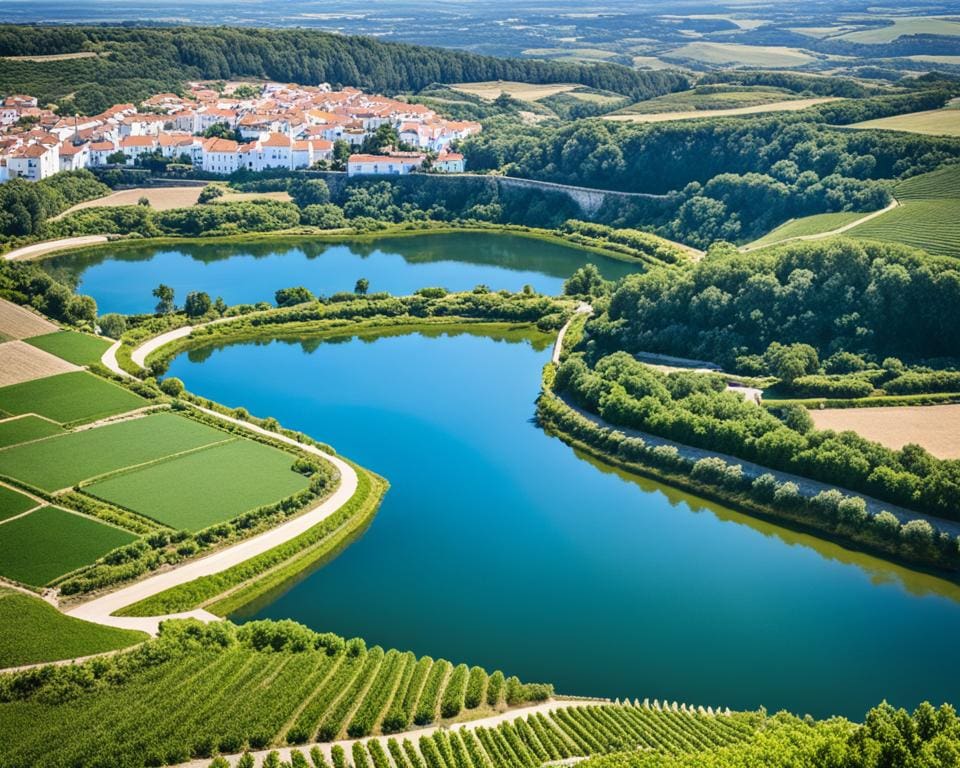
[0, 82, 481, 182]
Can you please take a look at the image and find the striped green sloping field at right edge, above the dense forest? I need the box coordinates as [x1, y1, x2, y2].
[849, 165, 960, 257]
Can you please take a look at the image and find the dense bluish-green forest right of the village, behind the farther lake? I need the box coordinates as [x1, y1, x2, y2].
[463, 91, 960, 247]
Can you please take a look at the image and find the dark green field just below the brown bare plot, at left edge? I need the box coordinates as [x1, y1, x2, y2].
[0, 371, 147, 424]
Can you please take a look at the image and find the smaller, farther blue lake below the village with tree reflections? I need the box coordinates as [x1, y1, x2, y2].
[43, 232, 637, 314]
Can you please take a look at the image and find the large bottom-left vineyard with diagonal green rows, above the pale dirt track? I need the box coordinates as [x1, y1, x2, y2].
[0, 621, 553, 768]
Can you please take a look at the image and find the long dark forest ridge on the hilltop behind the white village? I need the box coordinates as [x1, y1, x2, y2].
[0, 25, 689, 113]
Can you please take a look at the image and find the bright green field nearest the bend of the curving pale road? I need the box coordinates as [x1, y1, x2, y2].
[84, 440, 308, 531]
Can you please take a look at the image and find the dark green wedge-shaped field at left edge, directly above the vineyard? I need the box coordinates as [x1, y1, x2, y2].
[0, 589, 147, 667]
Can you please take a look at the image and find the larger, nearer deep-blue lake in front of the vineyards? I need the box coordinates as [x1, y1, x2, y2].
[170, 334, 960, 718]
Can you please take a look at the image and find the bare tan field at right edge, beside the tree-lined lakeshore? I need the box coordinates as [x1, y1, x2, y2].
[810, 405, 960, 459]
